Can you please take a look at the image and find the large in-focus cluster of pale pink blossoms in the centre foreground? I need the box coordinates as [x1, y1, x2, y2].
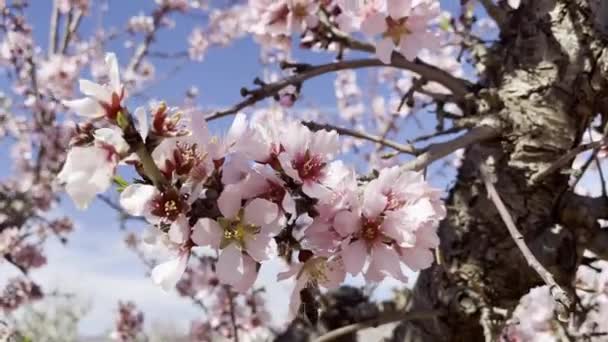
[59, 55, 445, 318]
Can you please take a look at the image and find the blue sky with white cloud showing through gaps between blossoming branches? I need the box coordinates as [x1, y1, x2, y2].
[0, 0, 480, 334]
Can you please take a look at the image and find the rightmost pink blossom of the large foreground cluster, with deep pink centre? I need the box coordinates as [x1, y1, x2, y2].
[334, 167, 445, 281]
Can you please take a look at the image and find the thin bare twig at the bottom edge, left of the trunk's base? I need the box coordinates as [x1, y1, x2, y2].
[314, 311, 439, 342]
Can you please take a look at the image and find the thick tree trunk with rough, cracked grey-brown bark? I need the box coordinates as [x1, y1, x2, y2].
[393, 0, 608, 341]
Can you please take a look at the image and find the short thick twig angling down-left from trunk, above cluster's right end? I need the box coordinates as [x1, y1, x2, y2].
[401, 125, 499, 171]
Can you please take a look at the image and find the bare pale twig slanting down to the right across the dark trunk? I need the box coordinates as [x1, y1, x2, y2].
[479, 166, 572, 321]
